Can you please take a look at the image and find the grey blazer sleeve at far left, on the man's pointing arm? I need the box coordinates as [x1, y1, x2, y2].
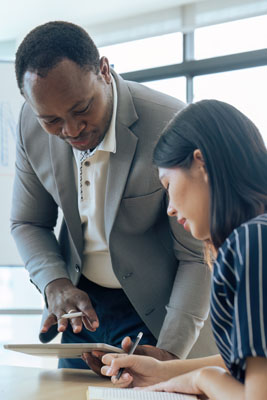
[11, 104, 69, 294]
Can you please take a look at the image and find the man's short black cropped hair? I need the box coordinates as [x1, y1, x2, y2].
[15, 21, 99, 92]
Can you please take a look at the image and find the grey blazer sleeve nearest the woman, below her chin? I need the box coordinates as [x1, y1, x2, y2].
[157, 211, 217, 358]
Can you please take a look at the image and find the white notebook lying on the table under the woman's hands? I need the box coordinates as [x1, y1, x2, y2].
[86, 386, 197, 400]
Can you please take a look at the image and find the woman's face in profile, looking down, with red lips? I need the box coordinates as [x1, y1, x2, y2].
[159, 150, 210, 240]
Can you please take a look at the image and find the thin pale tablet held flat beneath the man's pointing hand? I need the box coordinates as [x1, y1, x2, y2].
[4, 343, 124, 358]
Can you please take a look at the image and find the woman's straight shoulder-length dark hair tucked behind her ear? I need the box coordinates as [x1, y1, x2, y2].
[153, 100, 267, 249]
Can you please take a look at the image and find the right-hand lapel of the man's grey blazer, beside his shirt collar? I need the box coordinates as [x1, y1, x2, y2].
[105, 71, 138, 242]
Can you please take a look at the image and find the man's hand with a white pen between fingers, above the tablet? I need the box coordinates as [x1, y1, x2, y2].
[41, 278, 99, 333]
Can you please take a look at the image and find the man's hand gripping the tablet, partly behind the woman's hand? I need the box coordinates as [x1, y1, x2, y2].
[82, 336, 177, 376]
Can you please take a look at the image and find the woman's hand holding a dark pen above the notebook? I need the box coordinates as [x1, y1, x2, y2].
[101, 354, 166, 387]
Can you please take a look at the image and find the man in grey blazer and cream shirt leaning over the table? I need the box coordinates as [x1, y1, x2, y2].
[11, 22, 218, 370]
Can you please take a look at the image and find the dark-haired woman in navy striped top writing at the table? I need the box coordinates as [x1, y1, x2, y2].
[102, 100, 267, 400]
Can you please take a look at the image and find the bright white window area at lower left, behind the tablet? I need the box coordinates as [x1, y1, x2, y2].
[0, 267, 60, 368]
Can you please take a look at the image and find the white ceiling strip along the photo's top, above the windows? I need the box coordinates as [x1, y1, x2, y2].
[0, 0, 267, 50]
